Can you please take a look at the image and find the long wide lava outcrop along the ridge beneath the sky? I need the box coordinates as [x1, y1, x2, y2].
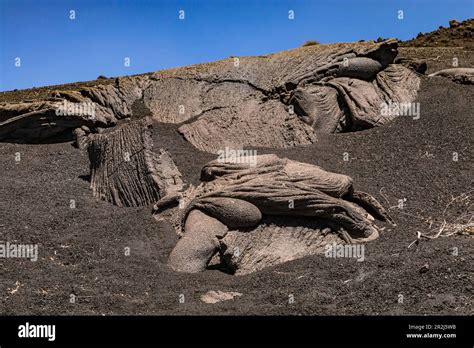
[0, 40, 419, 153]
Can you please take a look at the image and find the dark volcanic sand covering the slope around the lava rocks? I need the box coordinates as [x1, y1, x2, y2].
[0, 78, 474, 315]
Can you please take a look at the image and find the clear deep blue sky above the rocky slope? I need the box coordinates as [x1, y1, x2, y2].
[0, 0, 474, 91]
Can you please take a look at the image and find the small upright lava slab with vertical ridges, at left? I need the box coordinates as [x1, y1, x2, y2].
[85, 118, 183, 207]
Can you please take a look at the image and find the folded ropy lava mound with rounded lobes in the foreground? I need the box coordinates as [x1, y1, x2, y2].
[155, 155, 390, 274]
